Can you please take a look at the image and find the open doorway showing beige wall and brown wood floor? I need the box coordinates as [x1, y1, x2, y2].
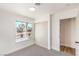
[60, 18, 76, 55]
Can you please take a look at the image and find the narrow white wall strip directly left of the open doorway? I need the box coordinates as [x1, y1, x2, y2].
[52, 14, 60, 51]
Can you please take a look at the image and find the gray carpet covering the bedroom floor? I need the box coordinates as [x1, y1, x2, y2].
[6, 45, 70, 56]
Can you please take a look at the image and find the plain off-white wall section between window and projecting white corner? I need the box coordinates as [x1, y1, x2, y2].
[35, 21, 48, 48]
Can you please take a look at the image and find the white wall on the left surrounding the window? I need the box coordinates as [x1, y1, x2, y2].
[0, 9, 34, 54]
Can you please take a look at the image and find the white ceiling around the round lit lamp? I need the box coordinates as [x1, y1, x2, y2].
[0, 3, 79, 19]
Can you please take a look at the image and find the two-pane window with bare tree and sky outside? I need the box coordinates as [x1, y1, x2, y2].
[16, 21, 32, 42]
